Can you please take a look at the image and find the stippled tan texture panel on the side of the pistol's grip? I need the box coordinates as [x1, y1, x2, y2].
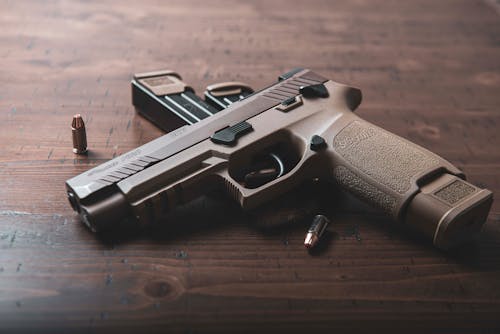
[333, 120, 440, 194]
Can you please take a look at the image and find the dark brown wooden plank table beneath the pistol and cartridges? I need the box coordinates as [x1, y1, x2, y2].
[0, 0, 500, 333]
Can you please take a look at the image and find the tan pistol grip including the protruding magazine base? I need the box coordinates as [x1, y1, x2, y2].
[332, 115, 493, 249]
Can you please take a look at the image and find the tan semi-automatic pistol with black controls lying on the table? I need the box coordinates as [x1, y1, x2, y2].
[66, 69, 493, 249]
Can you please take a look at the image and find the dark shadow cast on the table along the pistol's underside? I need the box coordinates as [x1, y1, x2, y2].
[94, 180, 500, 271]
